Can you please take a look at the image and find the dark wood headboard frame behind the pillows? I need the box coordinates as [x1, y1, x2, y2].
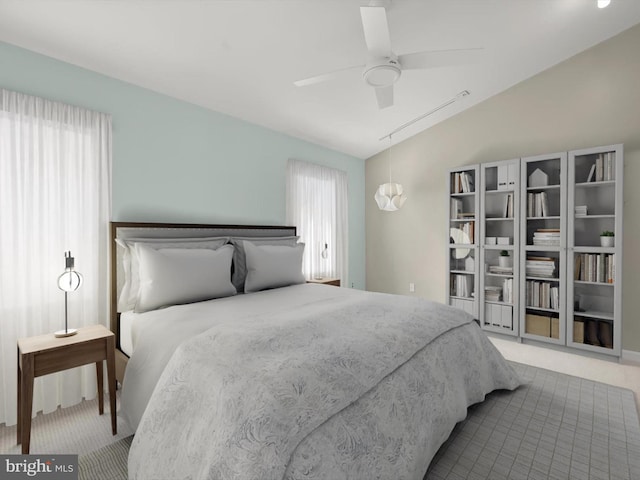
[109, 222, 296, 382]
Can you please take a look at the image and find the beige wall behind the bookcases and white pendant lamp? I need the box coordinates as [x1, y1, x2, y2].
[365, 22, 640, 351]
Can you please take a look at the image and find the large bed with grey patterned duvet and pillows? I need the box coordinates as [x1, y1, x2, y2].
[112, 224, 520, 480]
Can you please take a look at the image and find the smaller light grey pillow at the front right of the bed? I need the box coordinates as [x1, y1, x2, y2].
[242, 240, 305, 292]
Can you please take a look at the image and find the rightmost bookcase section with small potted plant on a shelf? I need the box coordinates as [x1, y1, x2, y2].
[567, 145, 624, 356]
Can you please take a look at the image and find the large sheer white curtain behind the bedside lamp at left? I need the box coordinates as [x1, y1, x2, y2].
[0, 89, 111, 425]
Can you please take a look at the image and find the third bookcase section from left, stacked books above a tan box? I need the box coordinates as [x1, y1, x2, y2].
[519, 152, 567, 345]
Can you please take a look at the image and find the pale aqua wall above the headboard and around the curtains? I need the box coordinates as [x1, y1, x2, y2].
[0, 42, 365, 289]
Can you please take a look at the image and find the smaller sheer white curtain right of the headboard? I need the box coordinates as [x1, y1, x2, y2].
[287, 160, 349, 286]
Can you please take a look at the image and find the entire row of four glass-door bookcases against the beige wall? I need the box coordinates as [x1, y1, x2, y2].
[447, 145, 624, 357]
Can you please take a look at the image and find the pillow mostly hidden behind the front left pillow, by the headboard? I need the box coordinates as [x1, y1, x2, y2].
[116, 237, 229, 312]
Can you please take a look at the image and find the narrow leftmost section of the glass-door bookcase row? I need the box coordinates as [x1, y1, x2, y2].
[446, 165, 479, 318]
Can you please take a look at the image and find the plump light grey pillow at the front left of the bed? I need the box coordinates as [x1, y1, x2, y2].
[135, 243, 236, 312]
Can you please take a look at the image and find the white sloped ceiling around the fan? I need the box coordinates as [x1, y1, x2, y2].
[0, 0, 640, 158]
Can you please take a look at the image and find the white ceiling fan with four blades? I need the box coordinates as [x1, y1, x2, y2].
[294, 6, 482, 109]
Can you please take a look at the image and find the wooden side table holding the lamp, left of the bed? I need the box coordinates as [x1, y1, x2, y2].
[17, 325, 117, 454]
